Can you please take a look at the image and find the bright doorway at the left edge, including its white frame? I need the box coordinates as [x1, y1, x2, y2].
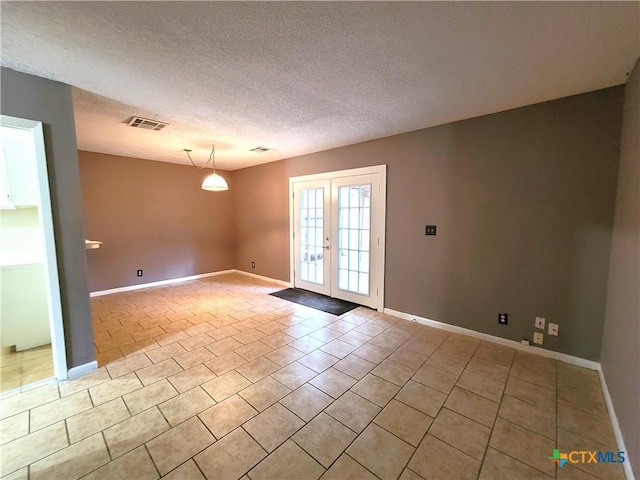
[0, 115, 67, 393]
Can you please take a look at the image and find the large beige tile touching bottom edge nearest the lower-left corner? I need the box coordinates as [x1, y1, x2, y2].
[29, 433, 110, 480]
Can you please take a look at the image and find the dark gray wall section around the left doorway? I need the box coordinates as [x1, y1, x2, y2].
[0, 67, 95, 368]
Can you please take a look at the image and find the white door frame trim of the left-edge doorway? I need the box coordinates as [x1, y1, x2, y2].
[0, 115, 67, 380]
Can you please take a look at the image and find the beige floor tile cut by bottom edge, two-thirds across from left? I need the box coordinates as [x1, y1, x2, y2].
[409, 435, 478, 480]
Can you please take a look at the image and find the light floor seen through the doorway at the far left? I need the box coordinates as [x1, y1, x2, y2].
[0, 344, 53, 392]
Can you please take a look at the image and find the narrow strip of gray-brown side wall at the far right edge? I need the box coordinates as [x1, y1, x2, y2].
[601, 61, 640, 477]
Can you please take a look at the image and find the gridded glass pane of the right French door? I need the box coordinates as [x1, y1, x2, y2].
[338, 184, 371, 295]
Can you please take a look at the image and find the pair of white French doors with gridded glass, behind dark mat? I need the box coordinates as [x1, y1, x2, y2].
[290, 166, 386, 310]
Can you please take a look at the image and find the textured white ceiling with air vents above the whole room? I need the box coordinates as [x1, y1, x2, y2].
[1, 1, 640, 170]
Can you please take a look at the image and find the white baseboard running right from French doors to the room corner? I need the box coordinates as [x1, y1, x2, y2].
[384, 308, 600, 370]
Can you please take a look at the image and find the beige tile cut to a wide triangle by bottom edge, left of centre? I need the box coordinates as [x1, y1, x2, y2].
[249, 440, 324, 480]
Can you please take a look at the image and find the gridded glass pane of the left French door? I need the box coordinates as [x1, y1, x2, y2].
[298, 188, 324, 285]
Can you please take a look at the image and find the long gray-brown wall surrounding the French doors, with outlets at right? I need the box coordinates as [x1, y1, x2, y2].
[232, 87, 624, 360]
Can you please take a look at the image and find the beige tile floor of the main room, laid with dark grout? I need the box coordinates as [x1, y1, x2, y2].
[0, 275, 624, 480]
